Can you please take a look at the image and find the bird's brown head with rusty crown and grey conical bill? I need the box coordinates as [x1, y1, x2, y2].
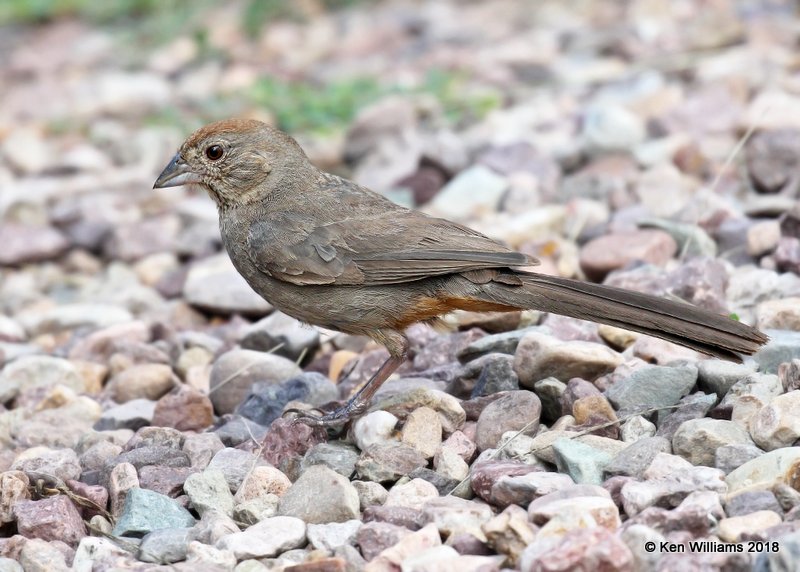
[153, 119, 314, 208]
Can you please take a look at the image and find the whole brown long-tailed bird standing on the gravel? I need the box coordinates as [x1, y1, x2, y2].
[154, 119, 767, 426]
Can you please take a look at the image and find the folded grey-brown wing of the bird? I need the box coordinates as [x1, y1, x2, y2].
[248, 208, 537, 285]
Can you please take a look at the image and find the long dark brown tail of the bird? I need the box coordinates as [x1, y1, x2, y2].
[481, 273, 768, 362]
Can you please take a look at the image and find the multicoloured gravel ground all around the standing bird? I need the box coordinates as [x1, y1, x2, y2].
[0, 0, 800, 572]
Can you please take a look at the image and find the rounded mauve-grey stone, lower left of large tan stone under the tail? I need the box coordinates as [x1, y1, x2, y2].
[475, 390, 542, 451]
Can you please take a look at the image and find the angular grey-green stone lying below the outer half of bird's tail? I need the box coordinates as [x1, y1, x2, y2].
[605, 365, 697, 414]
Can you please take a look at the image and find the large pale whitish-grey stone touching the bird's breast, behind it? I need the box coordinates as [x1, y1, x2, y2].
[183, 254, 272, 316]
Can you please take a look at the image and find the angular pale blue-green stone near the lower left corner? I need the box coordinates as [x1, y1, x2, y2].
[113, 488, 196, 537]
